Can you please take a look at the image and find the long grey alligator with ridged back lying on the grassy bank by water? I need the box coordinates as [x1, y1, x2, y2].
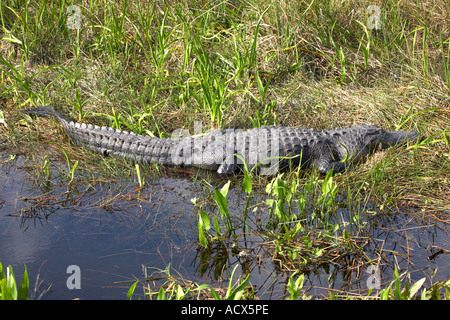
[22, 106, 419, 175]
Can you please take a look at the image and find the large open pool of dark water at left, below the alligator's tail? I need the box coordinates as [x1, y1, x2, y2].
[0, 154, 202, 299]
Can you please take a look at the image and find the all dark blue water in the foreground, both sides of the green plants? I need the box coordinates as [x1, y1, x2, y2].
[0, 155, 450, 299]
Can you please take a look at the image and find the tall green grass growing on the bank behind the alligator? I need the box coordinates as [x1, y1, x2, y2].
[0, 0, 449, 129]
